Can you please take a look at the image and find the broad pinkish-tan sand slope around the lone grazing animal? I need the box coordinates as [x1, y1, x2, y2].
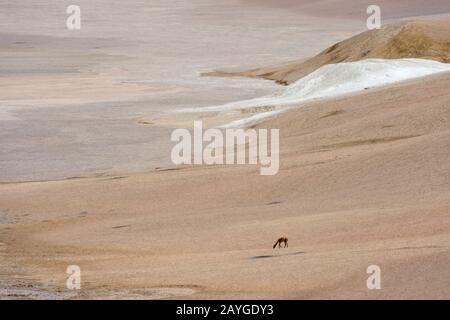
[0, 73, 450, 299]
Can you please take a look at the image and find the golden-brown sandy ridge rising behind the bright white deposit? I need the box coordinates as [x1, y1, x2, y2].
[206, 19, 450, 85]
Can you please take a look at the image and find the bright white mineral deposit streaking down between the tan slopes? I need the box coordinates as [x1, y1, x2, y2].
[183, 59, 450, 127]
